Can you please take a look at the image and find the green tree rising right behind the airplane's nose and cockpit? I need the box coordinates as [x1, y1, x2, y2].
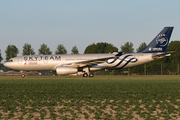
[5, 45, 19, 61]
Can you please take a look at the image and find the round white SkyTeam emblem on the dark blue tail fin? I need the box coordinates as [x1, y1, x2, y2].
[156, 34, 168, 47]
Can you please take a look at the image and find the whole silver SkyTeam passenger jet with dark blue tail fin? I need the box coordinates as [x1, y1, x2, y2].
[4, 27, 173, 77]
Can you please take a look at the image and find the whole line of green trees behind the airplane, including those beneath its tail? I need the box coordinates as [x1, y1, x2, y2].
[0, 41, 180, 75]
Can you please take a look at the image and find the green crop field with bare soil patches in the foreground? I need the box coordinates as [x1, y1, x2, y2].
[0, 76, 180, 120]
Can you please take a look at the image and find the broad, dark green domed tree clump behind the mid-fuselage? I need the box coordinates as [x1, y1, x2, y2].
[84, 42, 118, 53]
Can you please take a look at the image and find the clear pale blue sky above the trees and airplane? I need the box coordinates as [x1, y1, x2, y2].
[0, 0, 180, 62]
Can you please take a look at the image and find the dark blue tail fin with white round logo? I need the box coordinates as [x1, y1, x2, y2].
[139, 27, 174, 53]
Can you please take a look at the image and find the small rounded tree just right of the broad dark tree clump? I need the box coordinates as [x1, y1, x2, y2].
[121, 42, 134, 53]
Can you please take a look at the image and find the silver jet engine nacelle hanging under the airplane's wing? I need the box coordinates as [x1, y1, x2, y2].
[56, 66, 77, 75]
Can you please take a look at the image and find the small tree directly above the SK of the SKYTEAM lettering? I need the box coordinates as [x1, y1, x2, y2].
[22, 43, 35, 55]
